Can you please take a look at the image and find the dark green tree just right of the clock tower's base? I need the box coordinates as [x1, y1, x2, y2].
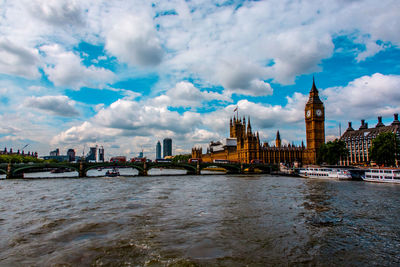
[317, 139, 349, 165]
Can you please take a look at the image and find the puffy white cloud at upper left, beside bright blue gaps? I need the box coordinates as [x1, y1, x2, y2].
[40, 45, 115, 89]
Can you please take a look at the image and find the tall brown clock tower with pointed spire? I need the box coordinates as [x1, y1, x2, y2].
[304, 77, 325, 164]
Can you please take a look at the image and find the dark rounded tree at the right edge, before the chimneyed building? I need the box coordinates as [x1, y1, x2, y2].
[368, 132, 400, 166]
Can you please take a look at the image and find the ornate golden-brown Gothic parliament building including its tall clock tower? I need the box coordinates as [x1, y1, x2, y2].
[192, 79, 325, 164]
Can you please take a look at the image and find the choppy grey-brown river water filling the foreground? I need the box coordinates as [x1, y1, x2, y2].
[0, 175, 400, 266]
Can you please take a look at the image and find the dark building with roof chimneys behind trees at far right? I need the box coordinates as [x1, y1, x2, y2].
[340, 114, 400, 165]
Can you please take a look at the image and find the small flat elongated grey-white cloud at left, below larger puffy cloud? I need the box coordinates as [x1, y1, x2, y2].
[25, 95, 79, 117]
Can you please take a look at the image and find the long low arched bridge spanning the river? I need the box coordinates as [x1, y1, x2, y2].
[0, 162, 277, 179]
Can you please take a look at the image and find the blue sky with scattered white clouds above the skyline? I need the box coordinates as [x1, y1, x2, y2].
[0, 0, 400, 158]
